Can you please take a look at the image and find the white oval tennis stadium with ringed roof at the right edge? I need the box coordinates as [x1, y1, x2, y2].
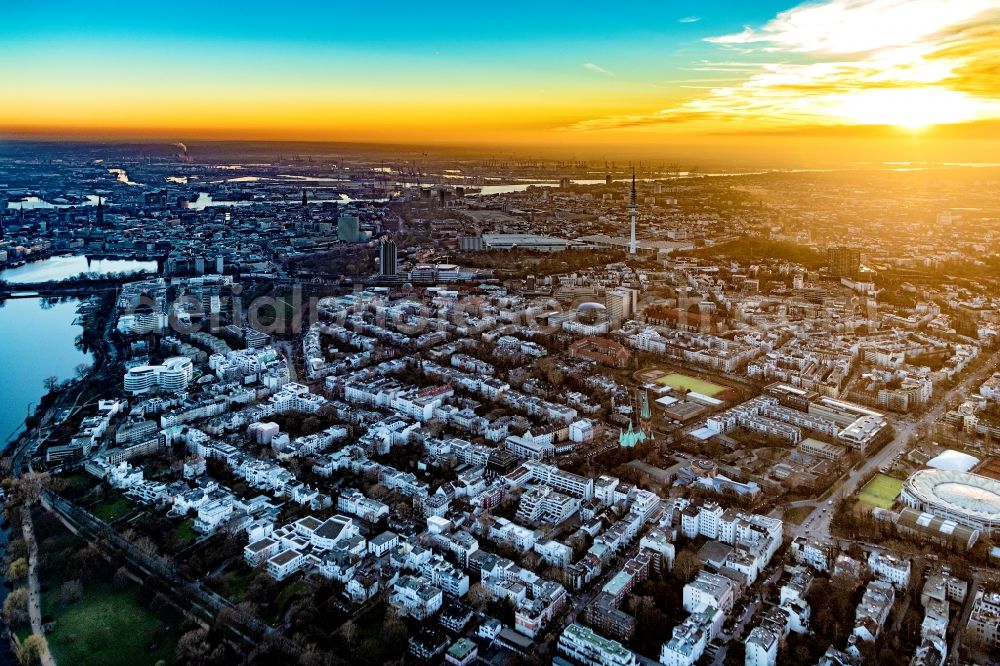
[901, 469, 1000, 533]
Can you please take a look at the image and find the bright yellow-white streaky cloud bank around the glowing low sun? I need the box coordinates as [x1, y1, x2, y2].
[563, 0, 1000, 131]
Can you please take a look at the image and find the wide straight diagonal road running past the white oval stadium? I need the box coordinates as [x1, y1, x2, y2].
[791, 350, 1000, 542]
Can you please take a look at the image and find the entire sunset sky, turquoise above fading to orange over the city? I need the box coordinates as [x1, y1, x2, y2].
[0, 0, 1000, 161]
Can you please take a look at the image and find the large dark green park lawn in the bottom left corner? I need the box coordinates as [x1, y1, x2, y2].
[46, 583, 177, 666]
